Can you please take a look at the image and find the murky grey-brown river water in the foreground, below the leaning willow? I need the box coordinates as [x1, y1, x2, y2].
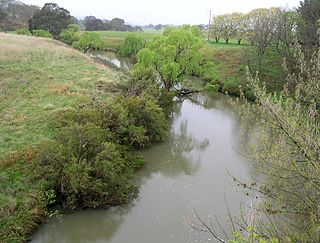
[32, 94, 256, 243]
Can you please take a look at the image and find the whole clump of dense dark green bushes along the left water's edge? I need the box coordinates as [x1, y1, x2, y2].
[29, 93, 168, 210]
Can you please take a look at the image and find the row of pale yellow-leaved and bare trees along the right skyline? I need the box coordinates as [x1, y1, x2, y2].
[208, 0, 320, 71]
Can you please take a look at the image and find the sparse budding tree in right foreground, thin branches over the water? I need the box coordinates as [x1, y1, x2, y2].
[236, 42, 320, 242]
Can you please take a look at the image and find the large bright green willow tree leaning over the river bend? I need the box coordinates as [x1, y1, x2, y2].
[136, 26, 205, 91]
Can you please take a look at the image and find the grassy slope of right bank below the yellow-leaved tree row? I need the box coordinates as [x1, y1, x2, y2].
[202, 39, 285, 95]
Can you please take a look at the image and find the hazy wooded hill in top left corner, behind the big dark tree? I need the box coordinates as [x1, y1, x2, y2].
[0, 0, 40, 31]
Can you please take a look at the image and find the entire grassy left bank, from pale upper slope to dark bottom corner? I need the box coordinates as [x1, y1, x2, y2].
[0, 34, 115, 242]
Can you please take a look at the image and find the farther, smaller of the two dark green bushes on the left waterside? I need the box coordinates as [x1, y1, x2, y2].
[103, 96, 168, 148]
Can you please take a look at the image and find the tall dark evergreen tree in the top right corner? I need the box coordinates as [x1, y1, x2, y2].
[298, 0, 320, 57]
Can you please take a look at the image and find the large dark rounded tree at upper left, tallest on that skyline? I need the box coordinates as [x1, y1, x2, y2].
[29, 3, 72, 39]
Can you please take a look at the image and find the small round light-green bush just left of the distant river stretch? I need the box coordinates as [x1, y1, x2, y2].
[73, 32, 105, 51]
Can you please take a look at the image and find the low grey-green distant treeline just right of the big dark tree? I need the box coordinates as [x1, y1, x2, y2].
[80, 16, 142, 32]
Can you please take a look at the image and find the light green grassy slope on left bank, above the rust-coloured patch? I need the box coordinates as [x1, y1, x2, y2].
[0, 34, 112, 154]
